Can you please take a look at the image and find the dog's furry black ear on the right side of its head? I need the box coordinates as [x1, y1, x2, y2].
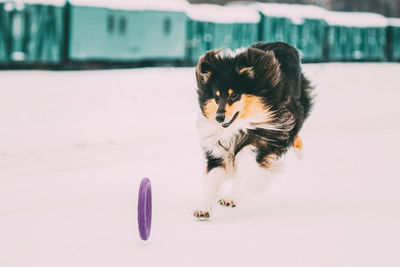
[236, 47, 281, 86]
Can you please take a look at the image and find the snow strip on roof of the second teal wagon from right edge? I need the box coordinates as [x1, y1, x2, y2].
[325, 11, 388, 27]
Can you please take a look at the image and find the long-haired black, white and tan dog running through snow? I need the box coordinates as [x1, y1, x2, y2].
[194, 42, 313, 220]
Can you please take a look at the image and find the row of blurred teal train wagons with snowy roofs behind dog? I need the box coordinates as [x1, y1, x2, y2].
[0, 0, 400, 68]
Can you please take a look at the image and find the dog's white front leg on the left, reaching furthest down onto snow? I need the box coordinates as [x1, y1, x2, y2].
[194, 167, 226, 220]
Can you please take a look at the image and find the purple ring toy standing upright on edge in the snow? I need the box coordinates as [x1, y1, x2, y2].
[138, 178, 151, 240]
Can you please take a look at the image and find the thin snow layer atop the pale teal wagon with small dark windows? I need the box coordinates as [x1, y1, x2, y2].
[69, 0, 189, 12]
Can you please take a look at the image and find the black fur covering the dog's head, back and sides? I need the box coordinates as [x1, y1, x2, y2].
[196, 42, 312, 171]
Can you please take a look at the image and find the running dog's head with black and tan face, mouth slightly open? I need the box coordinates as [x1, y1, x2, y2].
[196, 48, 282, 128]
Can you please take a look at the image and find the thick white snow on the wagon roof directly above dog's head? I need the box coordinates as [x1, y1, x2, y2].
[186, 4, 261, 23]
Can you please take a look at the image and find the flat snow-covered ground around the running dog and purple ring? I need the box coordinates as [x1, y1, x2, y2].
[0, 64, 400, 267]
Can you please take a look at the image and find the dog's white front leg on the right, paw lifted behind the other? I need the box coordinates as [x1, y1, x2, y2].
[218, 146, 284, 207]
